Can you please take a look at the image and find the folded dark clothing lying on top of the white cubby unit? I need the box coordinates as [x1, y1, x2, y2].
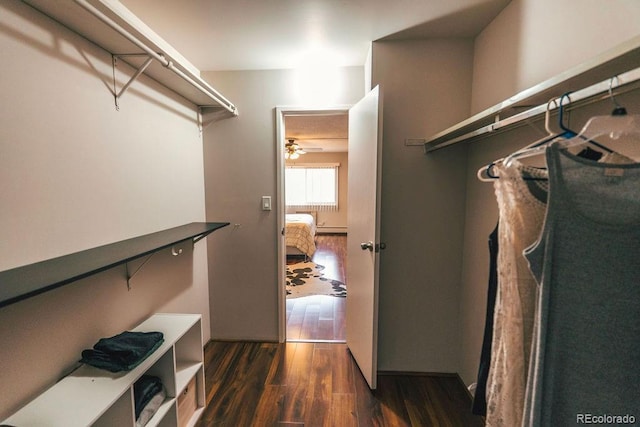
[80, 331, 164, 372]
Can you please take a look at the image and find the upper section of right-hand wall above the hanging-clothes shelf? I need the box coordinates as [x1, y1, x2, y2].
[471, 0, 640, 113]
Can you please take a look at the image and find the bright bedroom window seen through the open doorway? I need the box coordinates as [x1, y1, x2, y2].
[285, 164, 340, 210]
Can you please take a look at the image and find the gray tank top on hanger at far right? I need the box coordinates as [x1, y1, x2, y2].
[523, 144, 640, 426]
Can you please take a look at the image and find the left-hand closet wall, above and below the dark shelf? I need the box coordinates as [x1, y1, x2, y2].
[0, 0, 215, 419]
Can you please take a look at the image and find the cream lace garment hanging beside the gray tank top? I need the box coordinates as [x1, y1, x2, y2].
[486, 160, 547, 427]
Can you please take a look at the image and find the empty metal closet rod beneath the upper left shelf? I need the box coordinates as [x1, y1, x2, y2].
[74, 0, 238, 115]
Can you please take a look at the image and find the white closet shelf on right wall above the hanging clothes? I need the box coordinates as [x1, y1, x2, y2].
[422, 36, 640, 153]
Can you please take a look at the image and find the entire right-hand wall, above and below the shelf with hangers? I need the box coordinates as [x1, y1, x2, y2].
[460, 0, 640, 384]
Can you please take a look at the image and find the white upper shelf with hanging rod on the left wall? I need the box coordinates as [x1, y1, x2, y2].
[23, 0, 238, 116]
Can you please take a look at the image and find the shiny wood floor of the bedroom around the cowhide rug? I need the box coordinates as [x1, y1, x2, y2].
[287, 234, 349, 342]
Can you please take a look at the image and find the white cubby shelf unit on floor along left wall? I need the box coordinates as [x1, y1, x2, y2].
[0, 314, 205, 427]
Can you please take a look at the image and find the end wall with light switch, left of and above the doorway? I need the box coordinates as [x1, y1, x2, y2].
[203, 67, 364, 341]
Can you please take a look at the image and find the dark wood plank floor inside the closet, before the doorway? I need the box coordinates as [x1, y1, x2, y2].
[197, 341, 484, 427]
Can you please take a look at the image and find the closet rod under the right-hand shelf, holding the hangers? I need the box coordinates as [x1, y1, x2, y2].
[424, 68, 640, 154]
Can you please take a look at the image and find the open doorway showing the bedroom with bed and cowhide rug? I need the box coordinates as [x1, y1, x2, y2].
[278, 107, 348, 342]
